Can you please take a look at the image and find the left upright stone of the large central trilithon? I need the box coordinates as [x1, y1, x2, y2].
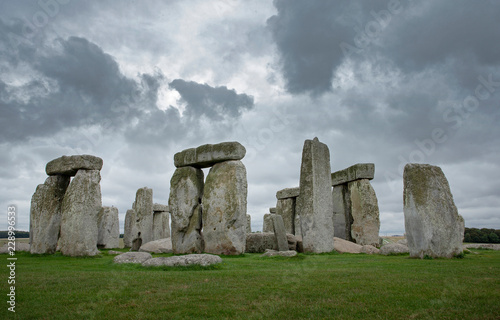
[168, 167, 204, 253]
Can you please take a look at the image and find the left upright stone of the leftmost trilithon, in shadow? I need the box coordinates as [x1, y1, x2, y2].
[30, 176, 70, 254]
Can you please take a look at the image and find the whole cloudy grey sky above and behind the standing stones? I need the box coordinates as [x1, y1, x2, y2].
[0, 0, 500, 235]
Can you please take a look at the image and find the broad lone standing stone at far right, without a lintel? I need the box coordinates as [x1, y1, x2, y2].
[403, 163, 464, 259]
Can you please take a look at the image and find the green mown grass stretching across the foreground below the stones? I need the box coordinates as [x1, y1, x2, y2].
[0, 250, 500, 319]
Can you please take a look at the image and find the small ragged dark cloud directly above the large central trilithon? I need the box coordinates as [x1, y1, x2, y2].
[169, 79, 254, 120]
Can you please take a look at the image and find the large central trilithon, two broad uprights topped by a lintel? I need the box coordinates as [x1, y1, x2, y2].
[169, 142, 247, 255]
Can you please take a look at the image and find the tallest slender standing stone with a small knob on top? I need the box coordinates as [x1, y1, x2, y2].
[297, 138, 334, 253]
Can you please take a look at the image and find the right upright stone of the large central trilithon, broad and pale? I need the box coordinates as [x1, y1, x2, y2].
[202, 161, 247, 255]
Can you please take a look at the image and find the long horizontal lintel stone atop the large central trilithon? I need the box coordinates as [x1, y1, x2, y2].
[174, 142, 246, 168]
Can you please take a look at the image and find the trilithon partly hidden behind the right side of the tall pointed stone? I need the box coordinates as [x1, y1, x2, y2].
[331, 163, 380, 246]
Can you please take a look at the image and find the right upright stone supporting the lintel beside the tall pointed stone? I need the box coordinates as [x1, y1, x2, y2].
[348, 179, 380, 247]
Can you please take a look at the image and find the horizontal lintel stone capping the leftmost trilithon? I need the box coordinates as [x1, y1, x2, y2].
[45, 155, 103, 176]
